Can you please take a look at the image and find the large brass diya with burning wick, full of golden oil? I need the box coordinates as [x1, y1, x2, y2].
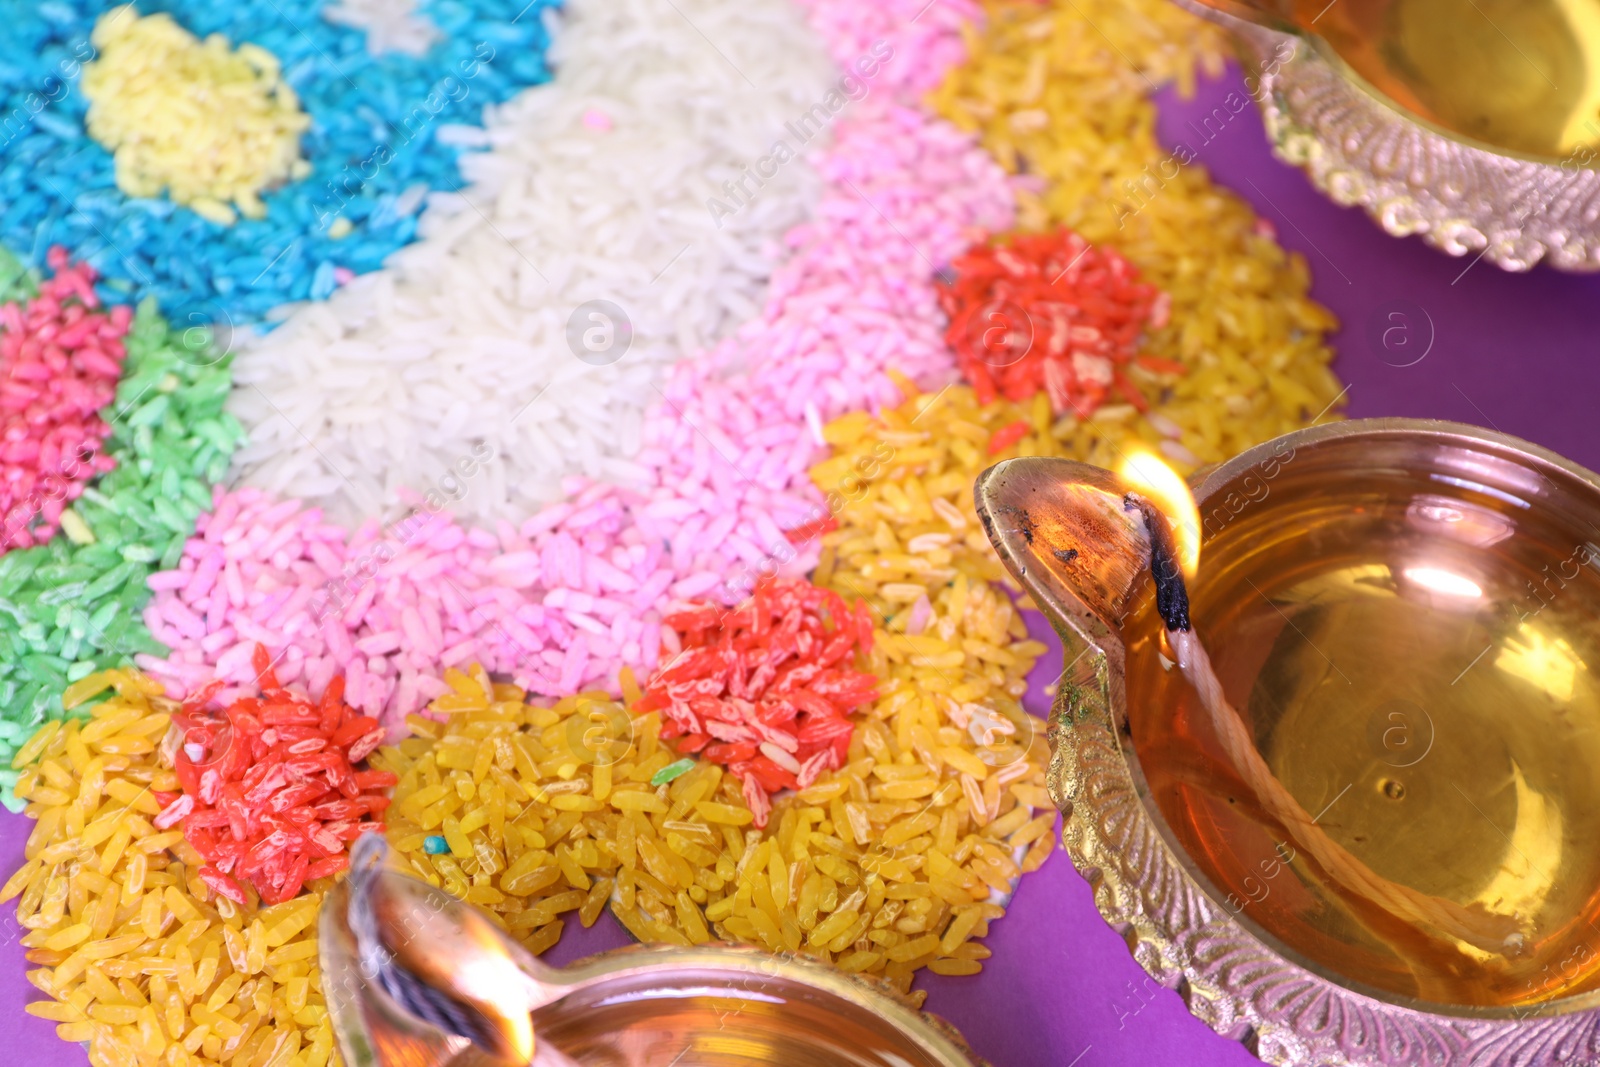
[978, 419, 1600, 1067]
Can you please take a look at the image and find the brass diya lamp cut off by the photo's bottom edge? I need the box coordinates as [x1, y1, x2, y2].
[318, 833, 984, 1067]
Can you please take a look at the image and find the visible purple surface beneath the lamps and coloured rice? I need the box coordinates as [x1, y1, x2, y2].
[0, 64, 1600, 1067]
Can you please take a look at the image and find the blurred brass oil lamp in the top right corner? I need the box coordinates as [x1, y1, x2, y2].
[1176, 0, 1600, 270]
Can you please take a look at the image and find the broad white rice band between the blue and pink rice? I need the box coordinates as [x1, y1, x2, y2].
[240, 0, 837, 526]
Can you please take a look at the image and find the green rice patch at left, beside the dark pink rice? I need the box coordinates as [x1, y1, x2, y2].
[0, 283, 240, 793]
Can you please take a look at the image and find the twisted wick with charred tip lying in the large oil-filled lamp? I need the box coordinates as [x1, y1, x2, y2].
[1123, 493, 1526, 957]
